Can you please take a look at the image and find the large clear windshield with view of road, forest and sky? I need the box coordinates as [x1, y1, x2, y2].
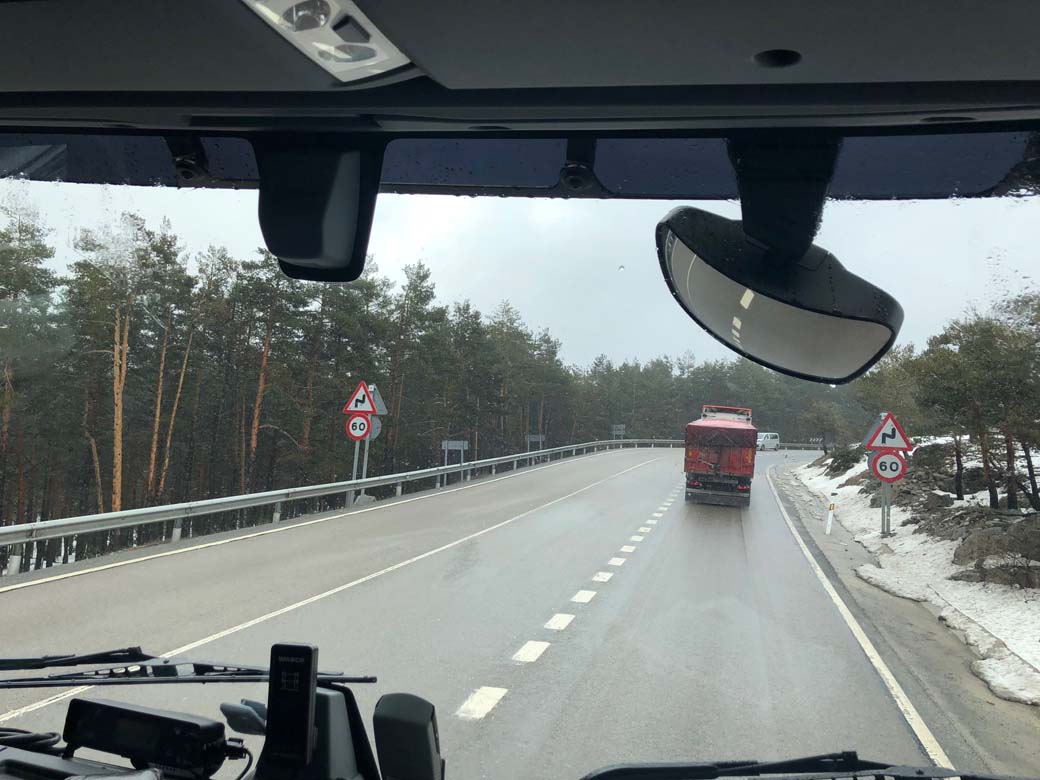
[0, 180, 1040, 780]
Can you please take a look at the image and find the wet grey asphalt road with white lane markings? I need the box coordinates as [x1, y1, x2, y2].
[0, 449, 1027, 779]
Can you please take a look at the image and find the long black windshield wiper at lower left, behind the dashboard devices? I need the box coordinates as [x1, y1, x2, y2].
[0, 653, 376, 690]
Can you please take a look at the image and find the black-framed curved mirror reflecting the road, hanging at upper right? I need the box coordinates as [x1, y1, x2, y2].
[657, 207, 903, 385]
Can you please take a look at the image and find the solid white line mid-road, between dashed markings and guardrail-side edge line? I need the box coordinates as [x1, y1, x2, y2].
[0, 458, 660, 723]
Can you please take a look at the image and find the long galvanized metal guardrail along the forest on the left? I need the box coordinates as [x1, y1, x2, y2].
[0, 439, 683, 547]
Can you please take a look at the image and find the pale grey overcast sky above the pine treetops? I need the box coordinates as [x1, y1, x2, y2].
[0, 181, 1040, 365]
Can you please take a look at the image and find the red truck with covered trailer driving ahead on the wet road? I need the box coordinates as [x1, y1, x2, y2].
[683, 404, 758, 506]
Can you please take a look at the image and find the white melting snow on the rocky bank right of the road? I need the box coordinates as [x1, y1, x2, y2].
[795, 459, 1040, 705]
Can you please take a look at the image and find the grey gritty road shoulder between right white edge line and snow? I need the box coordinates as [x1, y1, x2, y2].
[772, 466, 1040, 775]
